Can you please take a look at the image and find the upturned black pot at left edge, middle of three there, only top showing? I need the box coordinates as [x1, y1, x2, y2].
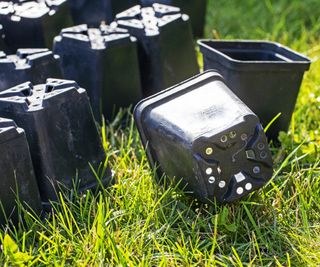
[0, 48, 62, 91]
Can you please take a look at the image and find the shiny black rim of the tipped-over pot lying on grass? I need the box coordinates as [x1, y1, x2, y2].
[133, 70, 224, 171]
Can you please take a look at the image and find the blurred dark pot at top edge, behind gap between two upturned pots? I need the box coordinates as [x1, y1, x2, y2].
[69, 0, 138, 27]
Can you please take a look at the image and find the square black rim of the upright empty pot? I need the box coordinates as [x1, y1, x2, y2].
[197, 39, 311, 71]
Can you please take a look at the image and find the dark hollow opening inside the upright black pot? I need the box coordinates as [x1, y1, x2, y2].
[220, 49, 291, 62]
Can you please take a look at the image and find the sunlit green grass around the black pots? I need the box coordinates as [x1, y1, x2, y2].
[0, 0, 320, 266]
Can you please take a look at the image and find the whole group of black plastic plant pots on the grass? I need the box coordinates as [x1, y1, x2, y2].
[0, 0, 310, 224]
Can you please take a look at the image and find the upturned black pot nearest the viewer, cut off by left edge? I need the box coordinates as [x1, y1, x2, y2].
[0, 118, 42, 225]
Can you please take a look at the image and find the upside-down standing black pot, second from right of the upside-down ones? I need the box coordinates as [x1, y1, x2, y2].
[54, 25, 142, 121]
